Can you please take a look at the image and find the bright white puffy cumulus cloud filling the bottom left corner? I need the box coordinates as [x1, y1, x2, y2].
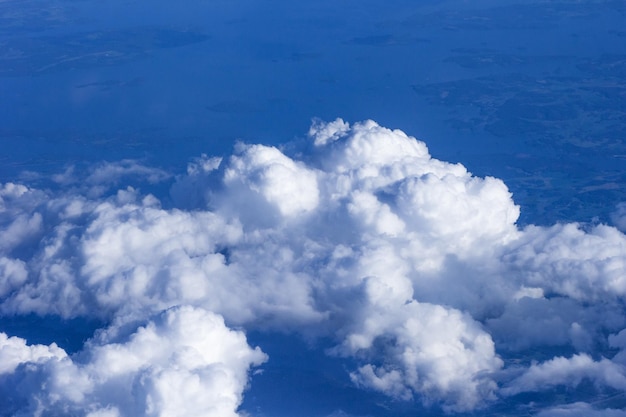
[0, 307, 266, 417]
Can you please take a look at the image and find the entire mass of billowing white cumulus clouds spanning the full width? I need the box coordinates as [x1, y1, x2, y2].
[0, 119, 626, 416]
